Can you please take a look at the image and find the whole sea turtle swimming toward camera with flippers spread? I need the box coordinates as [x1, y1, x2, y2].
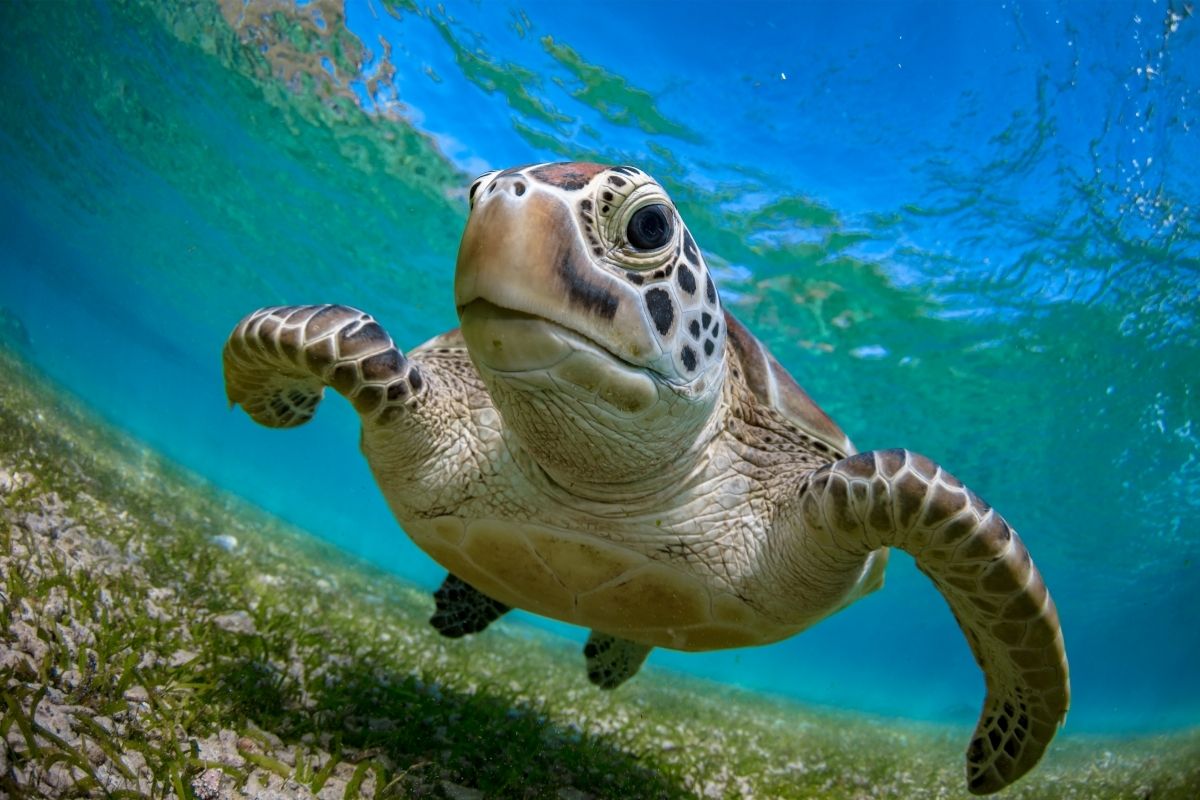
[224, 163, 1069, 794]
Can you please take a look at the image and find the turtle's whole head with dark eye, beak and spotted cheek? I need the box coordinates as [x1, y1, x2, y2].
[455, 163, 726, 483]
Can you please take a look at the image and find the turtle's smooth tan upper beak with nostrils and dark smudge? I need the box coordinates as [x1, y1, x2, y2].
[455, 173, 662, 368]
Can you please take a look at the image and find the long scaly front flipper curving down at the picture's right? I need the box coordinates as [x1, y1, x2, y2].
[800, 450, 1070, 794]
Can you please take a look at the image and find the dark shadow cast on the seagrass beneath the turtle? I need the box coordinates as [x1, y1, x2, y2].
[202, 642, 694, 800]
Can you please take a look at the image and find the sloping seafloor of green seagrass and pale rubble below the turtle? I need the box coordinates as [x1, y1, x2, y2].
[0, 347, 1200, 800]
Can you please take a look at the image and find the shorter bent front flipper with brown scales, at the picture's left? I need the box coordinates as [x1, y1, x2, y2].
[222, 306, 425, 428]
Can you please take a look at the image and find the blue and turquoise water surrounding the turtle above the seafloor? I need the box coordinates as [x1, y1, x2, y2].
[0, 0, 1200, 732]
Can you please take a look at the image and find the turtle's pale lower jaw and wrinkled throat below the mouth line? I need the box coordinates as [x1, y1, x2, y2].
[462, 305, 724, 499]
